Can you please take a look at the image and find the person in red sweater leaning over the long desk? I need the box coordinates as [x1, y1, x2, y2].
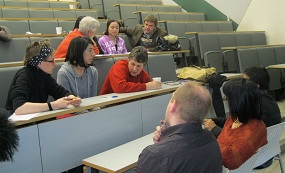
[100, 46, 162, 95]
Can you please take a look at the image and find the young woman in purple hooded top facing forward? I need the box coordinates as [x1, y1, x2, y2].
[98, 19, 127, 54]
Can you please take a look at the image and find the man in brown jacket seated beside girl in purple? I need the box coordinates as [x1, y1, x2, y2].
[120, 15, 167, 50]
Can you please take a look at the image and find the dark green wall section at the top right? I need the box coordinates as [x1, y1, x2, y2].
[173, 0, 238, 30]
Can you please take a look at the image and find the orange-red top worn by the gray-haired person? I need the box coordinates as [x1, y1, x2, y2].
[54, 28, 99, 58]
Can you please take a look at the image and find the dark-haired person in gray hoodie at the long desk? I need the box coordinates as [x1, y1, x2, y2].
[57, 37, 98, 98]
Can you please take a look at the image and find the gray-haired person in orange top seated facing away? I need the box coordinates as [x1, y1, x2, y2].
[54, 16, 100, 58]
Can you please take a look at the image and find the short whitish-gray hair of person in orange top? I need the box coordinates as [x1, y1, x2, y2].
[79, 16, 100, 34]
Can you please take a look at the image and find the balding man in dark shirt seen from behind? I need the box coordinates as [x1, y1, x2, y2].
[134, 81, 222, 173]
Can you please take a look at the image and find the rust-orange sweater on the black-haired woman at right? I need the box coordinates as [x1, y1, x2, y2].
[218, 117, 267, 170]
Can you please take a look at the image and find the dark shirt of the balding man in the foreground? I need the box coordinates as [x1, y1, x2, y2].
[134, 123, 222, 173]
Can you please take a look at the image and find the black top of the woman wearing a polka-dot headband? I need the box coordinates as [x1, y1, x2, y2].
[5, 66, 71, 113]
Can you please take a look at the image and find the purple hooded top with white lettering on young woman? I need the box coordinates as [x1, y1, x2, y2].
[98, 35, 127, 54]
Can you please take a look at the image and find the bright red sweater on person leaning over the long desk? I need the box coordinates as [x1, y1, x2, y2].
[100, 60, 151, 95]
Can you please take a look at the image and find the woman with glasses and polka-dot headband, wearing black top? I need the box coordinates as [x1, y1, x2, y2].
[5, 39, 81, 115]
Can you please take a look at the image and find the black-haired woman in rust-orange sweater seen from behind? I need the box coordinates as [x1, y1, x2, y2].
[218, 78, 267, 170]
